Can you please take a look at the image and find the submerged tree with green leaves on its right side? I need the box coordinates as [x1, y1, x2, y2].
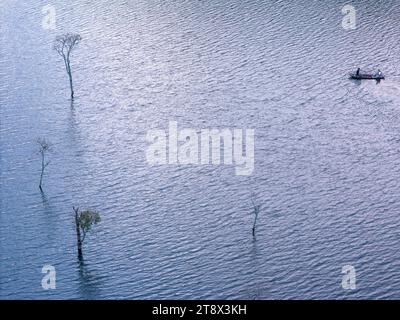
[73, 207, 101, 260]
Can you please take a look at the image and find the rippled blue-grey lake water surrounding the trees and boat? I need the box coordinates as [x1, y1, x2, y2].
[0, 0, 400, 299]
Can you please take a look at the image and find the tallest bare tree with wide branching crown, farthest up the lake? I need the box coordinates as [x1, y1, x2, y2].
[53, 33, 82, 99]
